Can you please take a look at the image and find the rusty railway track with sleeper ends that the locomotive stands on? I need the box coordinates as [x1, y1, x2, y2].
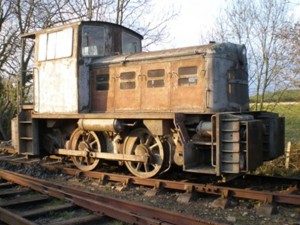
[0, 149, 300, 224]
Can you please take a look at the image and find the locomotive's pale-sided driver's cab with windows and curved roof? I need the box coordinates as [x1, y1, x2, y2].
[34, 21, 142, 113]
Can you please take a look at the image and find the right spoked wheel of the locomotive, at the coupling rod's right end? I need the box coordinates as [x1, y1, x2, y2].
[125, 128, 164, 178]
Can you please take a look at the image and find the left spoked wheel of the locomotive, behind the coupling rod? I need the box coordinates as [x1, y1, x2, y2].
[70, 128, 101, 171]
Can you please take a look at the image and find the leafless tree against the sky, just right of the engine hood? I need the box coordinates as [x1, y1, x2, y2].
[204, 0, 296, 110]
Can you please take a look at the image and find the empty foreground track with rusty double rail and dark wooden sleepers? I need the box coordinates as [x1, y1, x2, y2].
[0, 170, 219, 225]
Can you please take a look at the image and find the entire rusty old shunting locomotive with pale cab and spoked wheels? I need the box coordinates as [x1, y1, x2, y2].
[13, 21, 284, 178]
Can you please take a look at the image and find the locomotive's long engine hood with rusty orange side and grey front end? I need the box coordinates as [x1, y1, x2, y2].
[93, 44, 248, 113]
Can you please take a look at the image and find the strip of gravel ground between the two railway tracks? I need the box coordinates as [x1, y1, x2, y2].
[0, 161, 300, 225]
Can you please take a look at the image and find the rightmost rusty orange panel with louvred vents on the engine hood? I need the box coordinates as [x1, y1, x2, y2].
[170, 56, 206, 112]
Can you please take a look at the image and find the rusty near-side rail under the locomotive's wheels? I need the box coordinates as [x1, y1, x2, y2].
[44, 165, 300, 205]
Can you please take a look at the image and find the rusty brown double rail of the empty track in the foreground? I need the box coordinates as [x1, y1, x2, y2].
[0, 170, 220, 225]
